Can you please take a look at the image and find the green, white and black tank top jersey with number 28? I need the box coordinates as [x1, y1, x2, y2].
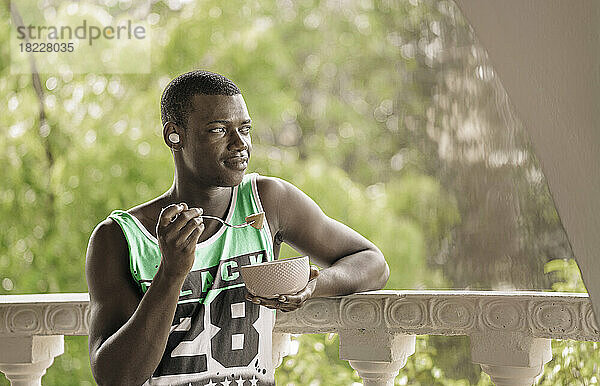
[109, 174, 275, 386]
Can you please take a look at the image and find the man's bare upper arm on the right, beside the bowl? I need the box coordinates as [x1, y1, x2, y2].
[259, 177, 381, 267]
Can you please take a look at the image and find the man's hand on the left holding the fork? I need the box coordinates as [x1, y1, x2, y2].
[156, 203, 204, 278]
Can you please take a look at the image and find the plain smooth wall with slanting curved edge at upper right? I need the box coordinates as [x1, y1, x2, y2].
[456, 0, 600, 321]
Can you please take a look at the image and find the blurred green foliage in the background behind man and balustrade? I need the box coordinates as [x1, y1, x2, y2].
[0, 0, 600, 385]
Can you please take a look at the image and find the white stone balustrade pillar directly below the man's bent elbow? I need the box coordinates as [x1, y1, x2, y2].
[339, 329, 416, 386]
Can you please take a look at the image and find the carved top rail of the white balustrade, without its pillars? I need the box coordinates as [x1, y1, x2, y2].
[0, 290, 600, 341]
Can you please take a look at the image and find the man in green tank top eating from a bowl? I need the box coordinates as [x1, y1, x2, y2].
[86, 71, 389, 386]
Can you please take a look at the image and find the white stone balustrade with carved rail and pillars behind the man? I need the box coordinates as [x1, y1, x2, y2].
[0, 291, 600, 386]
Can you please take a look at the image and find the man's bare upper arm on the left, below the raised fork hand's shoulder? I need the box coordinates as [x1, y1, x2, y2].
[85, 219, 141, 365]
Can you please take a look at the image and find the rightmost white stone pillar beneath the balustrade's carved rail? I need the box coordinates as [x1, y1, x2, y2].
[470, 332, 552, 386]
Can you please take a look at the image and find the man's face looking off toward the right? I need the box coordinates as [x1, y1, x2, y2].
[182, 94, 252, 186]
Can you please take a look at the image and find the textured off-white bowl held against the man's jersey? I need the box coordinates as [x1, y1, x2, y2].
[240, 256, 310, 299]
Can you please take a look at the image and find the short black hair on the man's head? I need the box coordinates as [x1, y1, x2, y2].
[160, 70, 241, 127]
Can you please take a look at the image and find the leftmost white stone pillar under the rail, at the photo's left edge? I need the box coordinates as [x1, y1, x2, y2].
[0, 335, 64, 386]
